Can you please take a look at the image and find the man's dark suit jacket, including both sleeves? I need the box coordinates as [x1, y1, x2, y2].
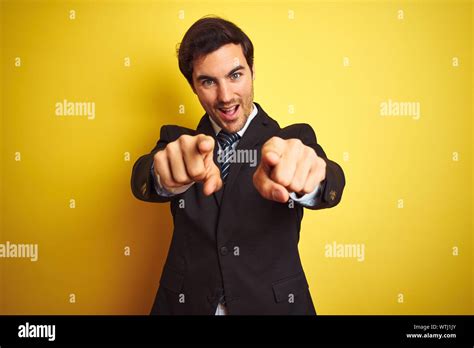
[131, 103, 345, 314]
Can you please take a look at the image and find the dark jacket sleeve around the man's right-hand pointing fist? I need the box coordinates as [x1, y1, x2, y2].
[280, 123, 346, 210]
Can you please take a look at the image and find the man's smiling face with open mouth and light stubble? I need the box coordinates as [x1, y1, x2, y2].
[193, 44, 255, 133]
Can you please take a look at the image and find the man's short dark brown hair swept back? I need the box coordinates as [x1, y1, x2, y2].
[176, 16, 253, 86]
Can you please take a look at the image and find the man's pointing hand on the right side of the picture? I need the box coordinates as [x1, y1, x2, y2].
[253, 137, 326, 203]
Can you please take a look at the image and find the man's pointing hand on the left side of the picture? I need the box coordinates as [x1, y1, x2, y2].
[153, 134, 222, 196]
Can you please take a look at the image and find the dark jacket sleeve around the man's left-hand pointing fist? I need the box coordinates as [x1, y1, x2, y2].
[131, 126, 194, 203]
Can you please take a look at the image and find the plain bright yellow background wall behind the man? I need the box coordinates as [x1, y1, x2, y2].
[0, 0, 474, 314]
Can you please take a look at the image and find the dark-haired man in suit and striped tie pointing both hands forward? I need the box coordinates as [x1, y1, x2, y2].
[131, 17, 345, 314]
